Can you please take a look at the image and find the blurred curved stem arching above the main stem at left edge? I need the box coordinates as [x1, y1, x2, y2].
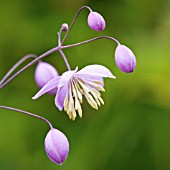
[0, 54, 37, 86]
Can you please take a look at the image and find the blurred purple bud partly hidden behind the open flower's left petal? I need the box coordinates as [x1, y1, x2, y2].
[34, 61, 58, 94]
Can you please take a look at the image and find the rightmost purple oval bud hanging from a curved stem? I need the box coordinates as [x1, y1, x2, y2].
[115, 44, 136, 73]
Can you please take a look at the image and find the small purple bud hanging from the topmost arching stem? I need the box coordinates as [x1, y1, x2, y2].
[88, 11, 106, 31]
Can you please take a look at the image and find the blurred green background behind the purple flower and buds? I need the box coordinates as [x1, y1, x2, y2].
[0, 0, 170, 170]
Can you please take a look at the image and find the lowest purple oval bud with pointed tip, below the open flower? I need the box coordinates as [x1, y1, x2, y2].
[45, 128, 69, 165]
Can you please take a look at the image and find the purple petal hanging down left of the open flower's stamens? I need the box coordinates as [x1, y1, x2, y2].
[55, 82, 69, 111]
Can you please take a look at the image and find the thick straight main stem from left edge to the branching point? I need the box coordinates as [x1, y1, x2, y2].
[0, 46, 59, 90]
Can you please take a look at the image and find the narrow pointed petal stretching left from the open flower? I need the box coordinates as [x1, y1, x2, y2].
[32, 76, 61, 99]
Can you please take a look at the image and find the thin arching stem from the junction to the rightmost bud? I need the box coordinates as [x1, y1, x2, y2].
[62, 36, 120, 49]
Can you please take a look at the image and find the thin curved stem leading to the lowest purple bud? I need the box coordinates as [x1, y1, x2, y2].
[0, 105, 53, 129]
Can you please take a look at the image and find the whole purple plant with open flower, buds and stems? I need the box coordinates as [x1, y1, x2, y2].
[0, 6, 136, 165]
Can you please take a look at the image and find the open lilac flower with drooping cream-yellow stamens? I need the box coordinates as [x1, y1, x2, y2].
[33, 65, 115, 120]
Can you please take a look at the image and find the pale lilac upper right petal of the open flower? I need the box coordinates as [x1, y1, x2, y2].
[76, 64, 116, 78]
